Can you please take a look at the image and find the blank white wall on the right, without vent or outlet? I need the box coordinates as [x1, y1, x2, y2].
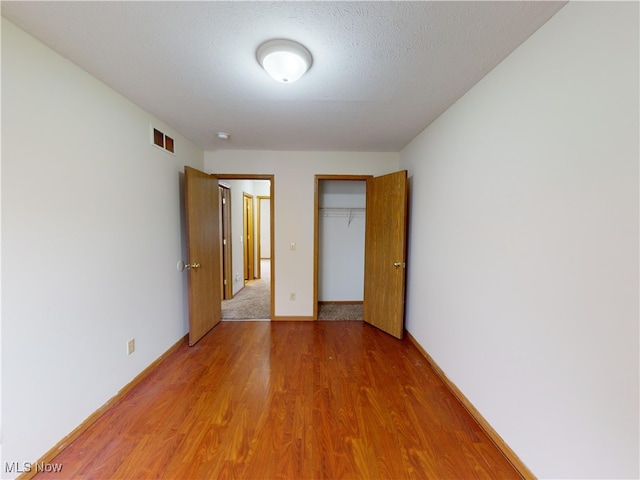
[400, 2, 640, 479]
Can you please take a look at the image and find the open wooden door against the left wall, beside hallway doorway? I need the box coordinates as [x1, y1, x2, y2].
[184, 167, 222, 345]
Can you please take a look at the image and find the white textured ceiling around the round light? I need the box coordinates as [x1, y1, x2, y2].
[2, 1, 564, 151]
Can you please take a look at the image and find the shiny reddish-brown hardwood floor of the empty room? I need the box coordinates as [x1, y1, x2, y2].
[35, 322, 521, 480]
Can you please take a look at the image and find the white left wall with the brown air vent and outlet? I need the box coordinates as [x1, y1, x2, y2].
[2, 19, 204, 476]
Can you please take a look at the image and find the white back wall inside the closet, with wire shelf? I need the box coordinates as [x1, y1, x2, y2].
[318, 180, 366, 302]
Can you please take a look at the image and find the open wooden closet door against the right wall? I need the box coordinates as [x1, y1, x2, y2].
[363, 170, 408, 338]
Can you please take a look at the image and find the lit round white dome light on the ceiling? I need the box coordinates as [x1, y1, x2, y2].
[256, 40, 312, 83]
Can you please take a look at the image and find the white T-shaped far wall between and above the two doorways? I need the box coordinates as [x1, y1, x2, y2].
[204, 150, 399, 317]
